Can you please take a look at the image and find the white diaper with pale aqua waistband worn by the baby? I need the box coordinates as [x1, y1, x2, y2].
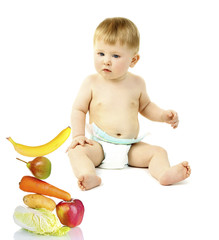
[87, 123, 144, 169]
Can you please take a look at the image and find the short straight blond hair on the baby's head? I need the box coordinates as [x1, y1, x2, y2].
[94, 17, 140, 53]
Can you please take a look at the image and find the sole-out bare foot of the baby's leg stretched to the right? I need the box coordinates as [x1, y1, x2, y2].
[160, 162, 191, 185]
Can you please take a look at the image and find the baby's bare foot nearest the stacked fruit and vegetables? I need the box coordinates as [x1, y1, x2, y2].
[78, 174, 101, 191]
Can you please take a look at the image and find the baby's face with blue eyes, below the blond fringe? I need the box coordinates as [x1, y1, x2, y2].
[94, 41, 134, 80]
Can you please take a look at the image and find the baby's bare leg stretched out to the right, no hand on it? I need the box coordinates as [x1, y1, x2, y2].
[129, 142, 191, 185]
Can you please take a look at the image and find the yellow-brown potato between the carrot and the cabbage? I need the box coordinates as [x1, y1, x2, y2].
[23, 194, 56, 211]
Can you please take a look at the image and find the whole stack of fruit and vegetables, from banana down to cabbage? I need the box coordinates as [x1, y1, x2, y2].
[7, 127, 84, 236]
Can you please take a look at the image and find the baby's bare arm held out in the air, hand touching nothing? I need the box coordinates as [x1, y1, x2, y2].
[139, 80, 179, 128]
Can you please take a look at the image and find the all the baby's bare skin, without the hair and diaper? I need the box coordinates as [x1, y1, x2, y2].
[67, 41, 191, 190]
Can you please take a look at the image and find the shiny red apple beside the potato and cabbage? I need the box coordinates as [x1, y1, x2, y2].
[56, 199, 84, 228]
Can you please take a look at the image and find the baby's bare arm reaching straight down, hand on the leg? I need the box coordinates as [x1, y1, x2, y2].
[67, 77, 92, 151]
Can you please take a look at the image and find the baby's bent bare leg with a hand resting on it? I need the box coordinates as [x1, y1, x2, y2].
[68, 141, 104, 190]
